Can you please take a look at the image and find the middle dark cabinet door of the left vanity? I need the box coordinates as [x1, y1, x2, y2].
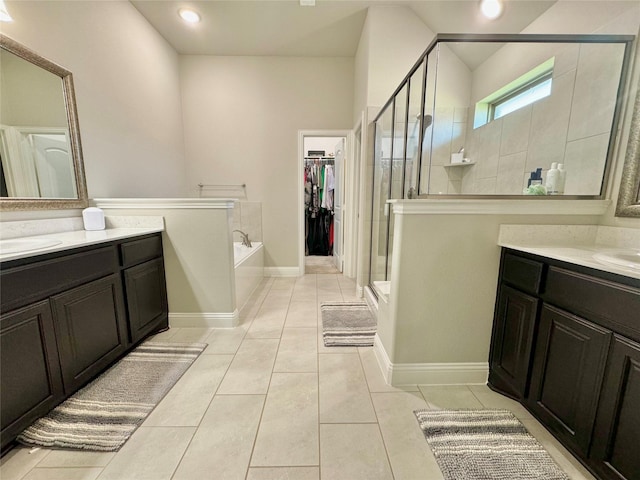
[51, 274, 127, 394]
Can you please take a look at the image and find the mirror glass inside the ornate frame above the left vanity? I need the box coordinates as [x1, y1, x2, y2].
[0, 46, 78, 199]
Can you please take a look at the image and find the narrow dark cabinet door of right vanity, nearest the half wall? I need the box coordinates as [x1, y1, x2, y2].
[489, 285, 538, 399]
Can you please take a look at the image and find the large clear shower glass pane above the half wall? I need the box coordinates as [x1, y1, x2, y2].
[399, 36, 627, 198]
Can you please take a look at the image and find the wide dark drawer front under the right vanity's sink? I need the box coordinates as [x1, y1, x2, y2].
[544, 267, 640, 341]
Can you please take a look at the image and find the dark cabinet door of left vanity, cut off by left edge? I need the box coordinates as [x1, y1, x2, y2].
[0, 300, 63, 450]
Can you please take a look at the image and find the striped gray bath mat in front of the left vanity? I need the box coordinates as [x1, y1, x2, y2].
[17, 342, 207, 452]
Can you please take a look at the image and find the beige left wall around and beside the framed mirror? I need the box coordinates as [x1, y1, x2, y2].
[2, 1, 186, 197]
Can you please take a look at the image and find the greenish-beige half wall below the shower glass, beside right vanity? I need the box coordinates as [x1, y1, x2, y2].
[379, 208, 598, 370]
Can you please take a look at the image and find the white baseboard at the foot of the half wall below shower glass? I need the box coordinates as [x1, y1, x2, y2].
[373, 335, 489, 387]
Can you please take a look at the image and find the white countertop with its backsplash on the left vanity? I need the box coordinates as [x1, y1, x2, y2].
[0, 216, 164, 262]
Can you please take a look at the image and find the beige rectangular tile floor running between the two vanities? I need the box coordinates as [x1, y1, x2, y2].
[0, 274, 593, 480]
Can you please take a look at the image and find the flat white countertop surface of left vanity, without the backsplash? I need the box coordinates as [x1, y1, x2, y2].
[0, 226, 164, 262]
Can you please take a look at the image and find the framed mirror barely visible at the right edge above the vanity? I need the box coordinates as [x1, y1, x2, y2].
[616, 79, 640, 217]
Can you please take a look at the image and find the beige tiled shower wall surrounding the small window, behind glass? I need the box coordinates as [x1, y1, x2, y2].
[429, 44, 622, 195]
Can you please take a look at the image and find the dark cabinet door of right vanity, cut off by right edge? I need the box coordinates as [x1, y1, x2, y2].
[590, 336, 640, 480]
